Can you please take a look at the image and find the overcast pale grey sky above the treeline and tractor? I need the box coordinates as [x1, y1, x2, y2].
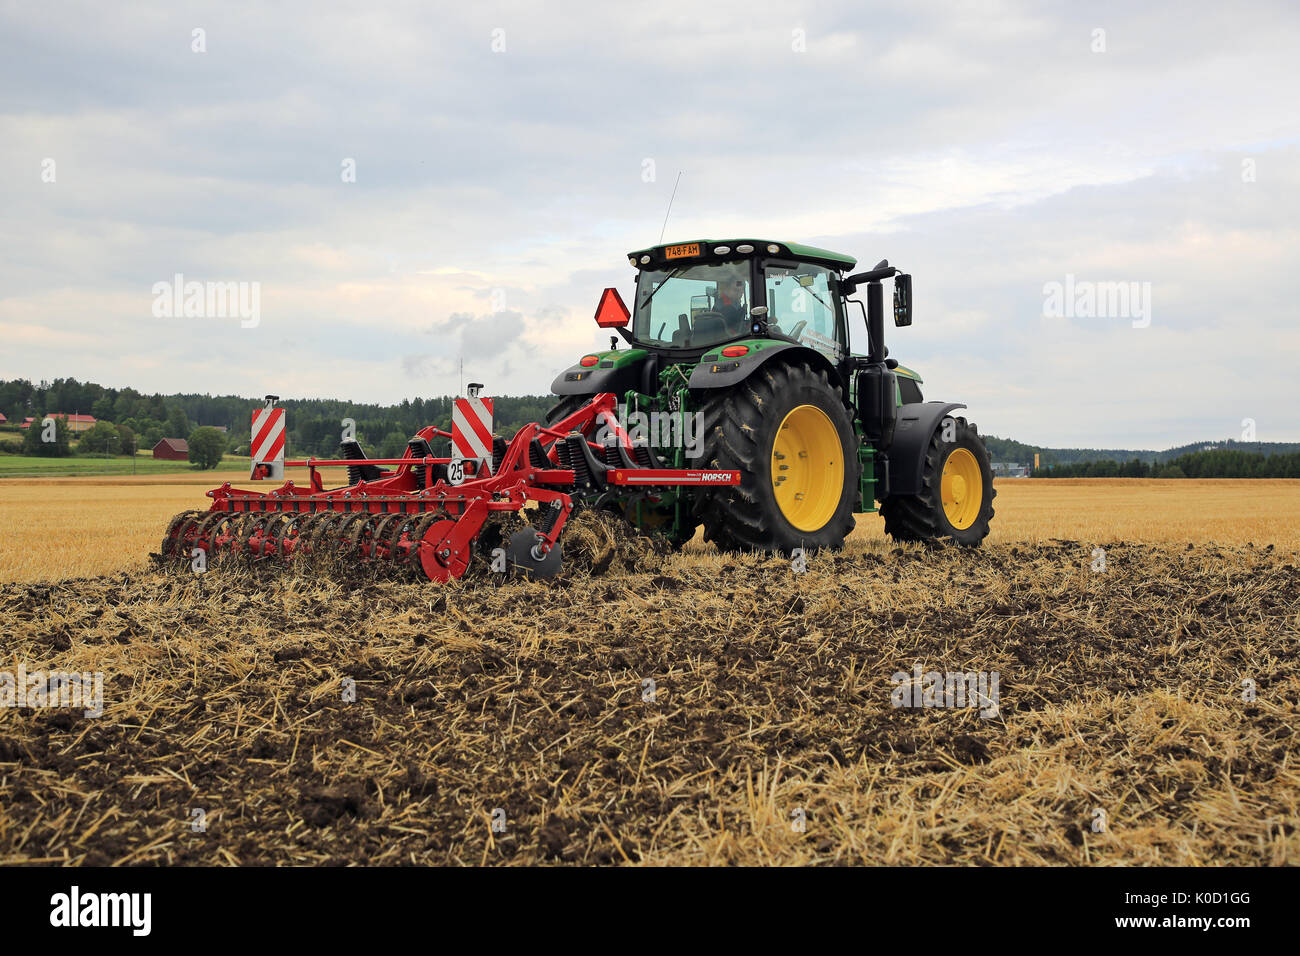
[0, 0, 1300, 447]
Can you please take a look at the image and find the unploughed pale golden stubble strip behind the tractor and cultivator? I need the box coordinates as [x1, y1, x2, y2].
[0, 476, 1300, 581]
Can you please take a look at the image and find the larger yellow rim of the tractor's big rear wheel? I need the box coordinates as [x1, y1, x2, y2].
[772, 405, 844, 531]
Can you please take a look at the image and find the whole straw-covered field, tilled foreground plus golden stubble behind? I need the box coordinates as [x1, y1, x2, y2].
[0, 480, 1300, 865]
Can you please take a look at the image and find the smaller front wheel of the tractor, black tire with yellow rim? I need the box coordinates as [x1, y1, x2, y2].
[880, 419, 997, 548]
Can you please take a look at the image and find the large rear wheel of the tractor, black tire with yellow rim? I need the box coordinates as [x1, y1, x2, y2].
[694, 362, 862, 554]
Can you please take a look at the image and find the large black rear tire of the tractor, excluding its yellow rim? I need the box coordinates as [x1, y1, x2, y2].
[694, 360, 862, 554]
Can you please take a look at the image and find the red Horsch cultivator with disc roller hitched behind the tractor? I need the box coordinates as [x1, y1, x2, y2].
[163, 394, 740, 581]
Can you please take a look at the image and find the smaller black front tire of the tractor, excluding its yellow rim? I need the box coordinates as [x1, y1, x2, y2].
[880, 418, 997, 548]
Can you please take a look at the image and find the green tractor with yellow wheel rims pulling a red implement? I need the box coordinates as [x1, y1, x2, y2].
[549, 239, 996, 554]
